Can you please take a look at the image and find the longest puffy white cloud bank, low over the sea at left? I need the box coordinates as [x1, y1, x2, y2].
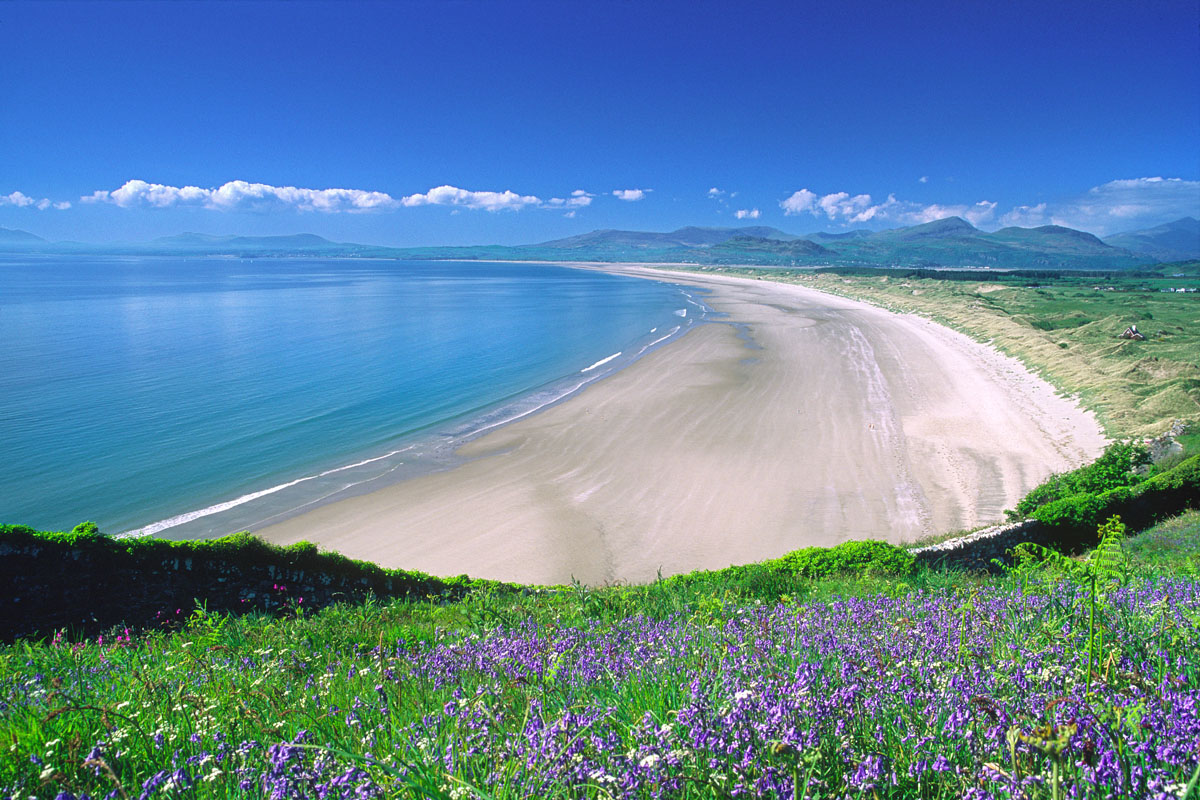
[87, 180, 396, 213]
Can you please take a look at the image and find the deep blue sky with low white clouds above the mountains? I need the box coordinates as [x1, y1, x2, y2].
[0, 0, 1200, 245]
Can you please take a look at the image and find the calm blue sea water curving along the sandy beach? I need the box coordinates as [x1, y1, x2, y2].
[0, 257, 701, 536]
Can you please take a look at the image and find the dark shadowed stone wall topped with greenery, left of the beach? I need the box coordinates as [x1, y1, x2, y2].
[0, 531, 468, 640]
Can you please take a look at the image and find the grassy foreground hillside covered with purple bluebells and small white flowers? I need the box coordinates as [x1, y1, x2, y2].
[0, 512, 1200, 800]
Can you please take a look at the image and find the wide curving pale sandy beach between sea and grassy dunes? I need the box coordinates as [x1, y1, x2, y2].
[256, 266, 1105, 585]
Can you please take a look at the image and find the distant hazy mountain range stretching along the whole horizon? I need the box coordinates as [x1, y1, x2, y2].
[0, 217, 1200, 270]
